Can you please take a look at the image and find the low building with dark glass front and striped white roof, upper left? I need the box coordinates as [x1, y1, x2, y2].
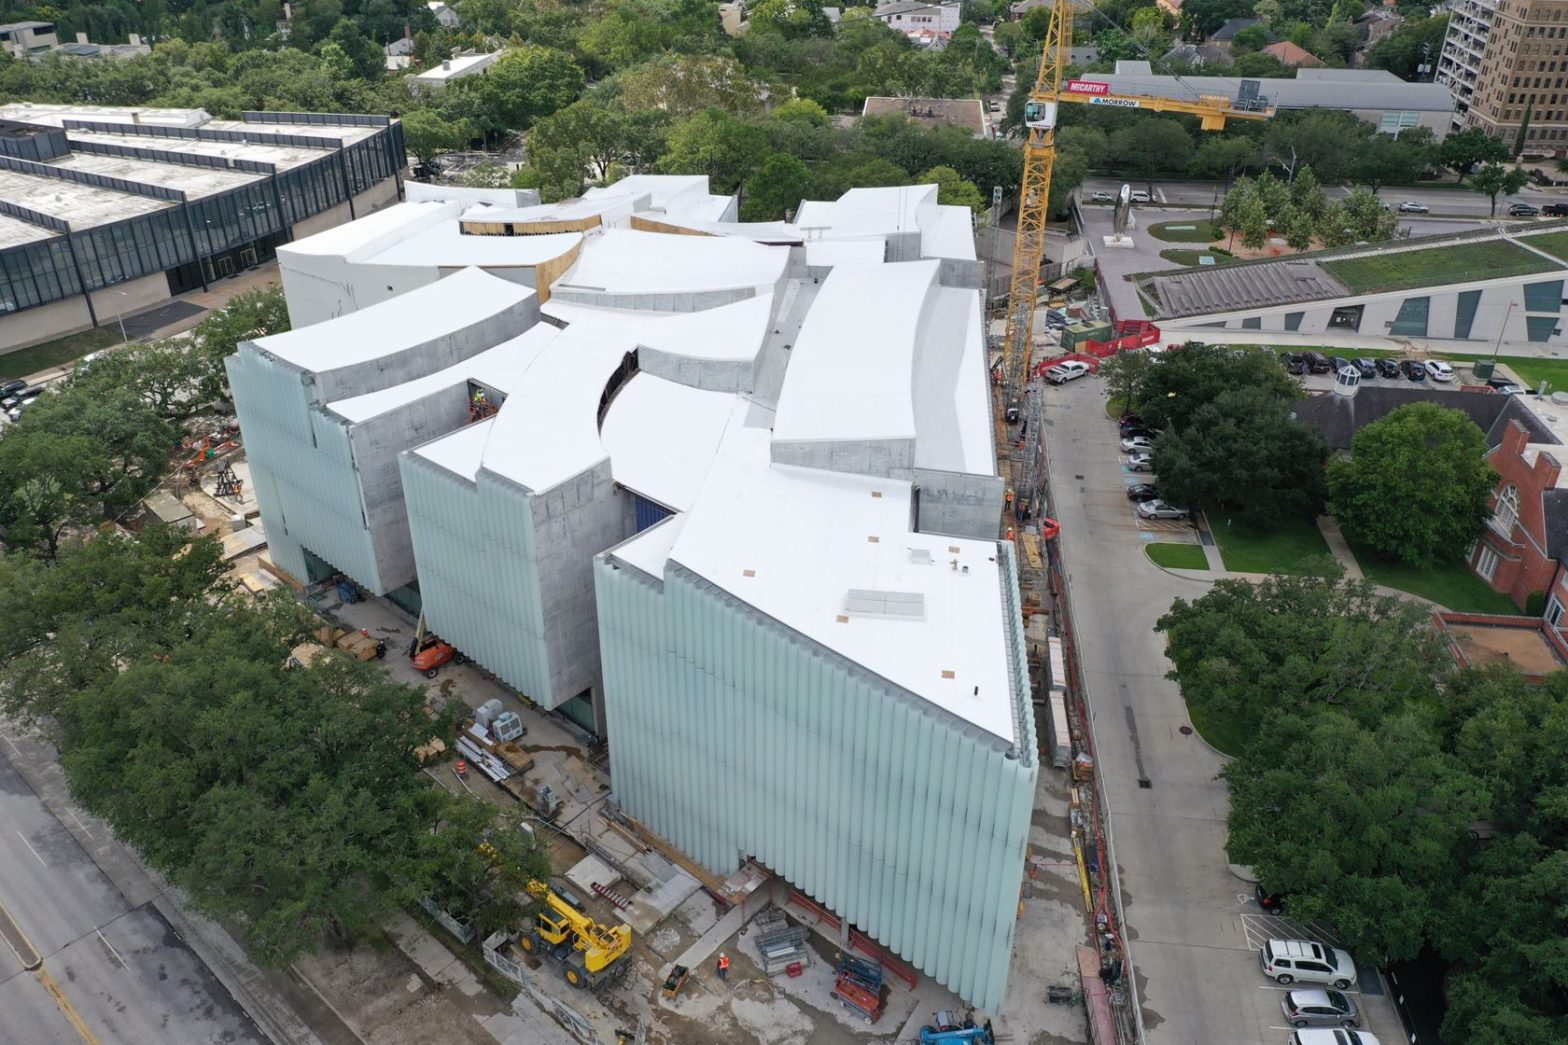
[0, 102, 406, 350]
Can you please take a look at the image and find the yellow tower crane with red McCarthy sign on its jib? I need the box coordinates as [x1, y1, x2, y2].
[1002, 0, 1275, 403]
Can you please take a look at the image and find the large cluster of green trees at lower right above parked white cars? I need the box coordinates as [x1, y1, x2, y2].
[1159, 563, 1568, 1045]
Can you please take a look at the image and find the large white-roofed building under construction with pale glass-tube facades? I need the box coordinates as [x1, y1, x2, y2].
[229, 176, 1038, 1012]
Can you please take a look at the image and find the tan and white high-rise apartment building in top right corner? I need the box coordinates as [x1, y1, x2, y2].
[1436, 0, 1568, 154]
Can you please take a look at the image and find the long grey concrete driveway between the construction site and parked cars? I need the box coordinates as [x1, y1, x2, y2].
[1044, 380, 1399, 1045]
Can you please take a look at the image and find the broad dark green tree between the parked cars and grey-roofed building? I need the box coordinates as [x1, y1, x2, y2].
[1154, 388, 1327, 529]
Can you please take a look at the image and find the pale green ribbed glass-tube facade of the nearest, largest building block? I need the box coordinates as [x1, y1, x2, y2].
[594, 543, 1038, 1012]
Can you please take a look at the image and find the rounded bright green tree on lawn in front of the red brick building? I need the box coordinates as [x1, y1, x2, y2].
[1328, 403, 1497, 566]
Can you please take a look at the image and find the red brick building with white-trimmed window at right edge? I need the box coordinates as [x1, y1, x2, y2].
[1469, 421, 1568, 612]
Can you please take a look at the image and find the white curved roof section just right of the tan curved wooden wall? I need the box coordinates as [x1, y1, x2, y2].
[555, 229, 789, 293]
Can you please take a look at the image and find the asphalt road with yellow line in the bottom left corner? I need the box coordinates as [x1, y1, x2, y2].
[0, 745, 267, 1045]
